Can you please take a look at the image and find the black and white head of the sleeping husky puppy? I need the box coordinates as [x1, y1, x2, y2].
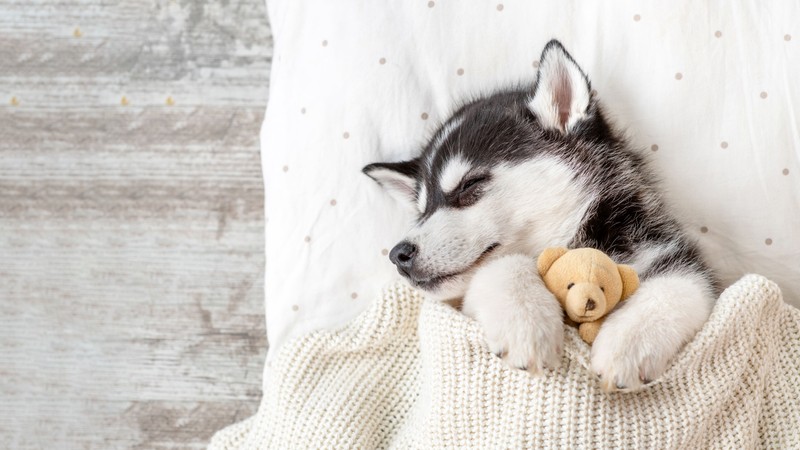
[363, 41, 611, 298]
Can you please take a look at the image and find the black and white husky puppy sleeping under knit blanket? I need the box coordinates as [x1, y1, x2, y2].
[364, 40, 716, 391]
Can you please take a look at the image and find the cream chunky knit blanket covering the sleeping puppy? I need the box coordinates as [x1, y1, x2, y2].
[210, 275, 800, 449]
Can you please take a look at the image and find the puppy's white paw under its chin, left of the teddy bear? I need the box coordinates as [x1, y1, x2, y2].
[464, 255, 564, 373]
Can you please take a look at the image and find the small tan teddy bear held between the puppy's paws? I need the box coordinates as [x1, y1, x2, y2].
[537, 247, 639, 344]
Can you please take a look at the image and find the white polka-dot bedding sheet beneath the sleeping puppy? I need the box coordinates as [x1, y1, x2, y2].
[262, 0, 800, 355]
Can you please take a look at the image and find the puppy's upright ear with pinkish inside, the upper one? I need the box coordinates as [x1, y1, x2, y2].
[528, 40, 592, 134]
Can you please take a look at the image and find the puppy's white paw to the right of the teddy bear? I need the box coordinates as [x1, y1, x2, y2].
[591, 275, 713, 392]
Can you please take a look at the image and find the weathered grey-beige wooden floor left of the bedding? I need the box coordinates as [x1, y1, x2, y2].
[0, 0, 272, 449]
